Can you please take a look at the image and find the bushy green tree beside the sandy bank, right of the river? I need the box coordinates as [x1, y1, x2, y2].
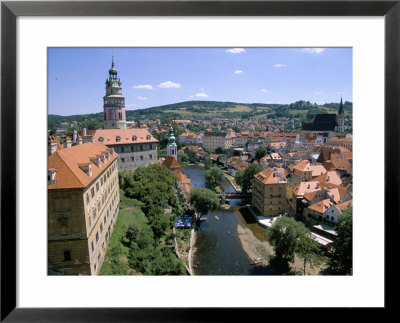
[267, 216, 309, 261]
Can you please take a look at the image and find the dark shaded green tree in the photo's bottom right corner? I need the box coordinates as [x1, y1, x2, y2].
[328, 207, 353, 275]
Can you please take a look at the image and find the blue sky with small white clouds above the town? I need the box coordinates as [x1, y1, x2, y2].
[48, 47, 353, 115]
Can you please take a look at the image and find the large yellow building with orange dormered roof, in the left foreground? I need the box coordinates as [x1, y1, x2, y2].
[47, 142, 119, 275]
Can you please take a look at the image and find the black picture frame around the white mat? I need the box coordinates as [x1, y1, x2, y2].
[0, 0, 400, 322]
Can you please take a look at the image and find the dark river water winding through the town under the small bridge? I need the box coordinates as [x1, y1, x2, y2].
[184, 165, 268, 275]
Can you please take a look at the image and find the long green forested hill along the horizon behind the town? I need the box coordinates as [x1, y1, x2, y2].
[48, 101, 353, 129]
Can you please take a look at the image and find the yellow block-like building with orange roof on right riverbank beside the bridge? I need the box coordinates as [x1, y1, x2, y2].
[252, 168, 287, 216]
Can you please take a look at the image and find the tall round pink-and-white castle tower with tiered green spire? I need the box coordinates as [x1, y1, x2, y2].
[103, 56, 126, 129]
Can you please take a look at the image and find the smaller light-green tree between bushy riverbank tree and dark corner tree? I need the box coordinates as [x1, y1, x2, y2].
[296, 233, 323, 275]
